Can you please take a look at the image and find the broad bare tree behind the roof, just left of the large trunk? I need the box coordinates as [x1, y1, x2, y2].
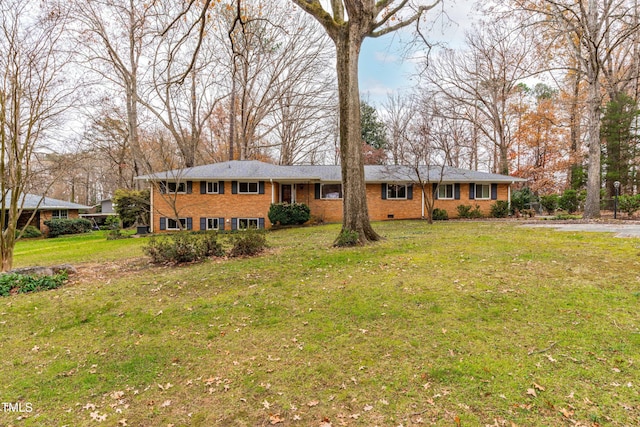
[214, 1, 335, 163]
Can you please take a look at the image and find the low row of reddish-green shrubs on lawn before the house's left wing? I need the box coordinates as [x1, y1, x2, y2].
[142, 229, 267, 264]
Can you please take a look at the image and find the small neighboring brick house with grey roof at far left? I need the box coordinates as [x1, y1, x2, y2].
[7, 192, 90, 234]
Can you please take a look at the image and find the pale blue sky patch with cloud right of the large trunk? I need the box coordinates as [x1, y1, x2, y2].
[359, 0, 475, 106]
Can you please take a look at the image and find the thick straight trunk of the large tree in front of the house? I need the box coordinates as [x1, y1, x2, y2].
[335, 22, 380, 244]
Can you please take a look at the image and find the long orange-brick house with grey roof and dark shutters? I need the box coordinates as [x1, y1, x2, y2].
[136, 160, 525, 232]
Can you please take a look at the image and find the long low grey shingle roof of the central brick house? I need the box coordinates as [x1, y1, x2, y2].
[136, 160, 526, 183]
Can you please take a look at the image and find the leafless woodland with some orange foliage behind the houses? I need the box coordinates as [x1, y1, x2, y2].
[0, 0, 640, 209]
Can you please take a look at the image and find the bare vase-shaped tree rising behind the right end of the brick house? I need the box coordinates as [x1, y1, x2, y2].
[427, 22, 538, 175]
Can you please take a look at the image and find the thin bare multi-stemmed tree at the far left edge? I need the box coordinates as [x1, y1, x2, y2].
[0, 0, 74, 271]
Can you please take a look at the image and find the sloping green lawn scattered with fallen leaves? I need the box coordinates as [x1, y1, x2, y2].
[0, 221, 640, 426]
